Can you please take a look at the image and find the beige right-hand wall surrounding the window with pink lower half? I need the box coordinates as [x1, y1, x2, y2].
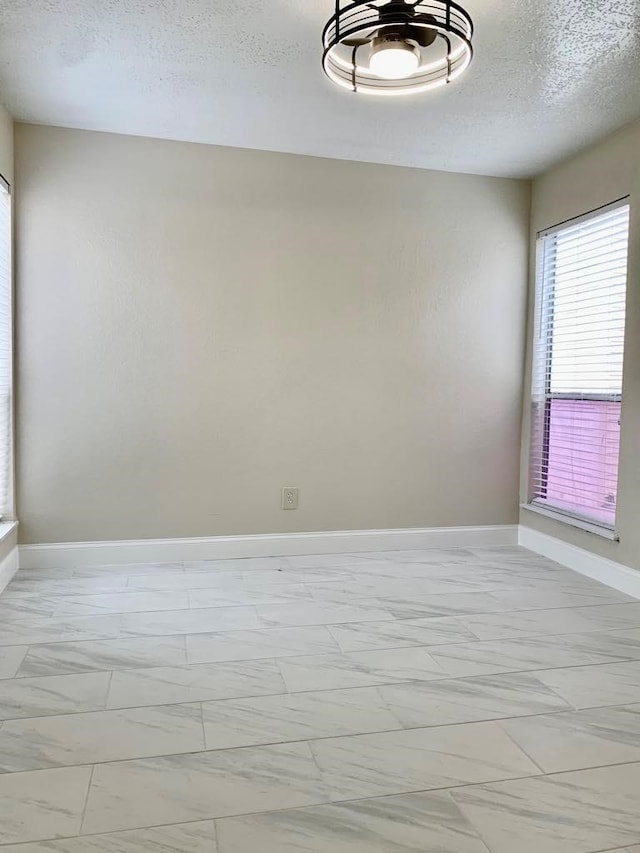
[520, 122, 640, 568]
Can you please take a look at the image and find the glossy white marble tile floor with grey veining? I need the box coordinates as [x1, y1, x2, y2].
[0, 547, 640, 853]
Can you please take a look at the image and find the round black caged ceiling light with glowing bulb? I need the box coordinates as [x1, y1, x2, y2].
[322, 0, 473, 95]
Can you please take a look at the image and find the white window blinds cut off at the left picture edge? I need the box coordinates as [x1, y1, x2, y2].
[0, 177, 13, 520]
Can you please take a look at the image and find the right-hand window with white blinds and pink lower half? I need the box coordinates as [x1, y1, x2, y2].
[529, 200, 629, 529]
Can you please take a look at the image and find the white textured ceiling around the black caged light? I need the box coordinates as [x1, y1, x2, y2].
[0, 0, 640, 177]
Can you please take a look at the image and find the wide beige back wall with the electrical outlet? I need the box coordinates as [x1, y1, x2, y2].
[16, 125, 530, 543]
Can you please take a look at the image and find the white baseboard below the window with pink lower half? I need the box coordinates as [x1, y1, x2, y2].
[518, 525, 640, 598]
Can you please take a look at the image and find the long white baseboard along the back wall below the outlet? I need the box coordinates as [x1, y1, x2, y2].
[20, 524, 518, 569]
